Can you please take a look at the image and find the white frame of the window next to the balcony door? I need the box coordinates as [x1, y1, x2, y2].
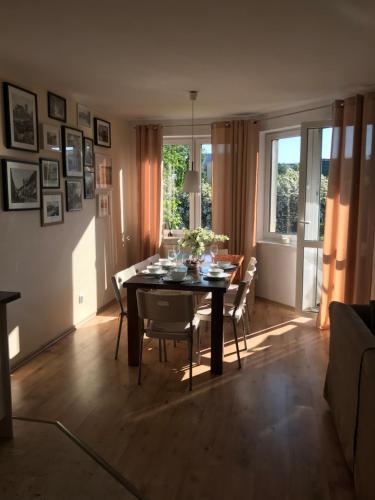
[263, 127, 301, 245]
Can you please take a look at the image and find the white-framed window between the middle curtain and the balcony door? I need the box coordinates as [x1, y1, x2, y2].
[265, 130, 301, 238]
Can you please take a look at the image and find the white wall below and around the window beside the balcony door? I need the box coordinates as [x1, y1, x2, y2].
[256, 106, 331, 307]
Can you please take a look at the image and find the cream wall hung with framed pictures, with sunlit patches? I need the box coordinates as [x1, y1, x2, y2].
[0, 78, 131, 364]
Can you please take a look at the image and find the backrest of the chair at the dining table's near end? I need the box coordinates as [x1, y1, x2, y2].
[137, 289, 194, 323]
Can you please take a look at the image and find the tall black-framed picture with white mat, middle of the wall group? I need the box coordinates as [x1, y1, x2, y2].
[61, 126, 83, 177]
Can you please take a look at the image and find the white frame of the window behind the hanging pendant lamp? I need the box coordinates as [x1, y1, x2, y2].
[161, 135, 212, 238]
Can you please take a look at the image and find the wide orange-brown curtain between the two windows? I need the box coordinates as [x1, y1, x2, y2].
[211, 120, 259, 263]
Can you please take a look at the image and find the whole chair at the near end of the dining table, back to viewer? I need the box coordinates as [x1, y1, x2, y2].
[137, 289, 199, 391]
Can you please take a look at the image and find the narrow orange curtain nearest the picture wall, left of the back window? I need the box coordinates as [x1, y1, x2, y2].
[136, 125, 163, 260]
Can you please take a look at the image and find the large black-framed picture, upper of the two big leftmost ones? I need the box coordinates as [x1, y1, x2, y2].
[3, 83, 39, 153]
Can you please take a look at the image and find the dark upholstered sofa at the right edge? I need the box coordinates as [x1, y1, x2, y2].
[324, 301, 375, 500]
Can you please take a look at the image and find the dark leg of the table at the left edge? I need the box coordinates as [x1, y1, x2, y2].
[0, 304, 13, 439]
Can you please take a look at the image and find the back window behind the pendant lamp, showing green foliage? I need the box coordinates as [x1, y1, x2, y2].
[163, 138, 212, 233]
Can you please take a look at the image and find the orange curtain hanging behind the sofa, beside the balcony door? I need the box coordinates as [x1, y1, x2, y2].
[318, 94, 375, 328]
